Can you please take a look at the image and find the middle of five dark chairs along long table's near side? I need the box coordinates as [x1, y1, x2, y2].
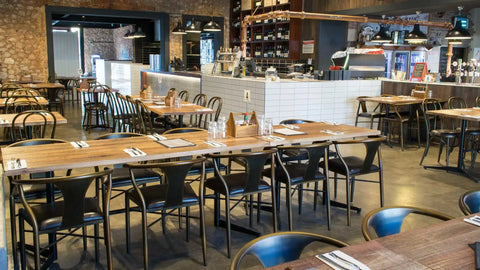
[205, 148, 277, 258]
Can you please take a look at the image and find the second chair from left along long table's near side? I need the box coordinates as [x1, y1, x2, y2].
[125, 158, 207, 269]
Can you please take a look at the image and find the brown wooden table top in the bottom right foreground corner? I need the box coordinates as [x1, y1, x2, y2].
[269, 217, 480, 270]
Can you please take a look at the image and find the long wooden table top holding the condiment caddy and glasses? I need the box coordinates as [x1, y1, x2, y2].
[1, 123, 379, 175]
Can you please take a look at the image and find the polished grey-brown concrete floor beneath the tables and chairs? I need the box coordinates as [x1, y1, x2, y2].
[7, 100, 480, 269]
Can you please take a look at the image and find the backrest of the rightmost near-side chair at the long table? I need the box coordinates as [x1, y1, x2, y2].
[333, 136, 385, 174]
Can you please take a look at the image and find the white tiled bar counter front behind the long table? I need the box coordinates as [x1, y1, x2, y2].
[201, 75, 382, 125]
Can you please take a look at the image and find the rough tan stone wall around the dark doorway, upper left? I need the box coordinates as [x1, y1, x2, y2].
[0, 0, 230, 80]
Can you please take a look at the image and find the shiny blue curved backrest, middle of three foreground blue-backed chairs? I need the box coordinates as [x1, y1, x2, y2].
[362, 206, 453, 241]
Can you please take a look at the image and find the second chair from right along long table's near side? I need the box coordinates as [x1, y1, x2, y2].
[264, 142, 331, 231]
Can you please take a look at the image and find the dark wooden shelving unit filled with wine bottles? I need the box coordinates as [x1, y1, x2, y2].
[230, 0, 302, 60]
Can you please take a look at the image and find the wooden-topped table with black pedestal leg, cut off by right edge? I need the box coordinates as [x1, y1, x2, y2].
[424, 108, 480, 183]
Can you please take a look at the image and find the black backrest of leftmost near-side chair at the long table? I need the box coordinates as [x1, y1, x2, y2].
[12, 168, 112, 229]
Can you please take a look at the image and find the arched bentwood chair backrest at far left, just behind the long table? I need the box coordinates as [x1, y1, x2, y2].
[10, 110, 57, 142]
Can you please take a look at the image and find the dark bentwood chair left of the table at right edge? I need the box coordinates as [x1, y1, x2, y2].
[420, 99, 460, 166]
